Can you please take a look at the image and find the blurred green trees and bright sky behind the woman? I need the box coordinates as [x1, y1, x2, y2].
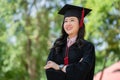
[0, 0, 120, 80]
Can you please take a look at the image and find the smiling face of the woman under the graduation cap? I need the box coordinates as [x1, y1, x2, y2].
[63, 17, 79, 37]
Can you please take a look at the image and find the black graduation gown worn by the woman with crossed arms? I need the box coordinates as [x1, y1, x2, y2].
[46, 41, 95, 80]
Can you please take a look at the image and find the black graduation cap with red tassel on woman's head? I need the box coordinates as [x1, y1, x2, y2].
[58, 4, 91, 27]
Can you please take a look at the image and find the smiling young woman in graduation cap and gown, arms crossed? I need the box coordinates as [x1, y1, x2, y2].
[44, 4, 95, 80]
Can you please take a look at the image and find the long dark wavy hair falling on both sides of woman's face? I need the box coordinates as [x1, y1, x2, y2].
[52, 23, 85, 53]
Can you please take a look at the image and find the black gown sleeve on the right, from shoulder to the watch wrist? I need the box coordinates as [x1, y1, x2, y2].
[66, 43, 95, 80]
